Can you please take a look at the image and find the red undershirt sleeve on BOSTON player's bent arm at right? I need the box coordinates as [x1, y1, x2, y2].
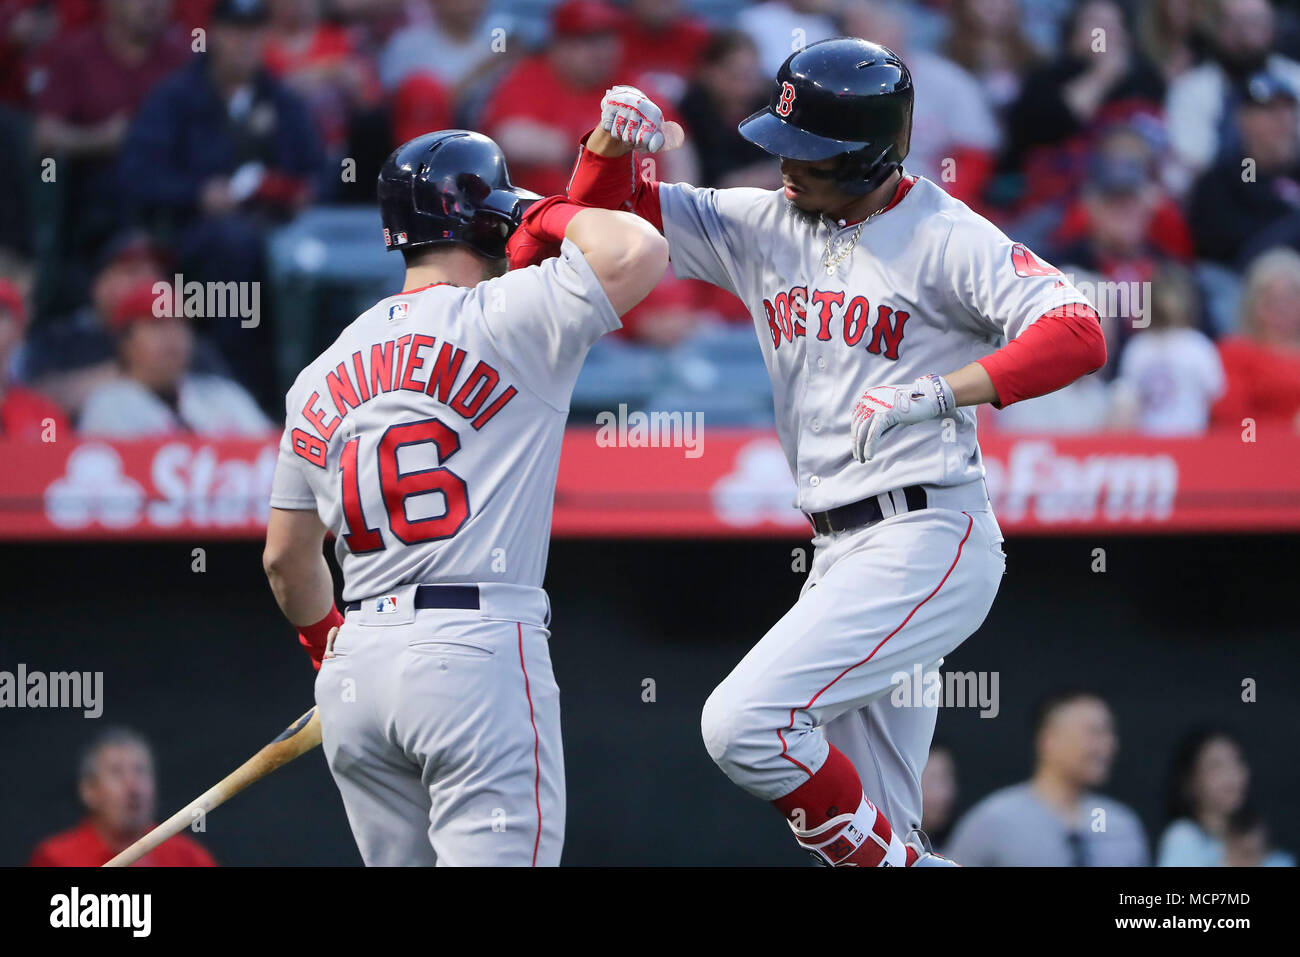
[978, 304, 1106, 408]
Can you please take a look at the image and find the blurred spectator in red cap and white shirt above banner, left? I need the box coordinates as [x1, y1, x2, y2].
[78, 283, 272, 438]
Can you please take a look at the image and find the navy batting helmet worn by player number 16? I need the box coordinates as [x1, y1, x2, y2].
[380, 130, 541, 259]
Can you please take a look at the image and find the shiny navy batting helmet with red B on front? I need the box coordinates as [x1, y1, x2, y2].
[740, 36, 913, 195]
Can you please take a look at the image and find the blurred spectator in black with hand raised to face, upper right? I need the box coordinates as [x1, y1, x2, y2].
[1004, 0, 1164, 207]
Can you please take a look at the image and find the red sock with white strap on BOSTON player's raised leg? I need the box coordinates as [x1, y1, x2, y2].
[772, 745, 915, 867]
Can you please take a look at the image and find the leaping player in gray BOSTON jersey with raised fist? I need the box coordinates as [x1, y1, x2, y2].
[568, 38, 1105, 866]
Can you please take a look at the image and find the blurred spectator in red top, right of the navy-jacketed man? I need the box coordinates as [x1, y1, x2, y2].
[264, 0, 380, 156]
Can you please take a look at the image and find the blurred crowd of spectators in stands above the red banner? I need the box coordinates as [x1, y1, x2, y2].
[0, 0, 1300, 437]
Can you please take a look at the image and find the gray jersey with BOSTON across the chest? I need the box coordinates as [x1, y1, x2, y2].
[659, 177, 1088, 511]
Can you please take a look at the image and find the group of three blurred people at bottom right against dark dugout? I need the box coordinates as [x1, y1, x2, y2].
[922, 688, 1296, 867]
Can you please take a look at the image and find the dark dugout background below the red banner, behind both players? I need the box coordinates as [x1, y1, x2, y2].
[0, 537, 1300, 865]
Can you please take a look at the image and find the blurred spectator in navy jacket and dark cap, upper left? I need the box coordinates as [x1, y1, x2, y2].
[121, 0, 328, 394]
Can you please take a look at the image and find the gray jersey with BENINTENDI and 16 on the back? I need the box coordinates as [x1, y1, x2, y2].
[270, 242, 620, 601]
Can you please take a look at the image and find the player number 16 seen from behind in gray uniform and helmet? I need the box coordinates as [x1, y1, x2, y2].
[264, 130, 667, 865]
